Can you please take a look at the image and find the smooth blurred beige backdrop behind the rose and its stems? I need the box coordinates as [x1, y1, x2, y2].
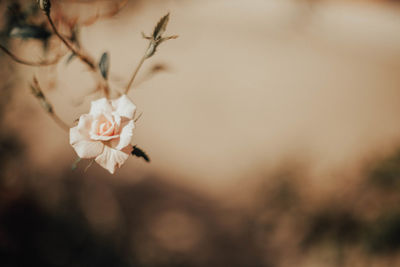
[9, 0, 400, 199]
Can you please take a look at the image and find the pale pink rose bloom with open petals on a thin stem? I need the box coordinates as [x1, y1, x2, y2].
[69, 95, 136, 173]
